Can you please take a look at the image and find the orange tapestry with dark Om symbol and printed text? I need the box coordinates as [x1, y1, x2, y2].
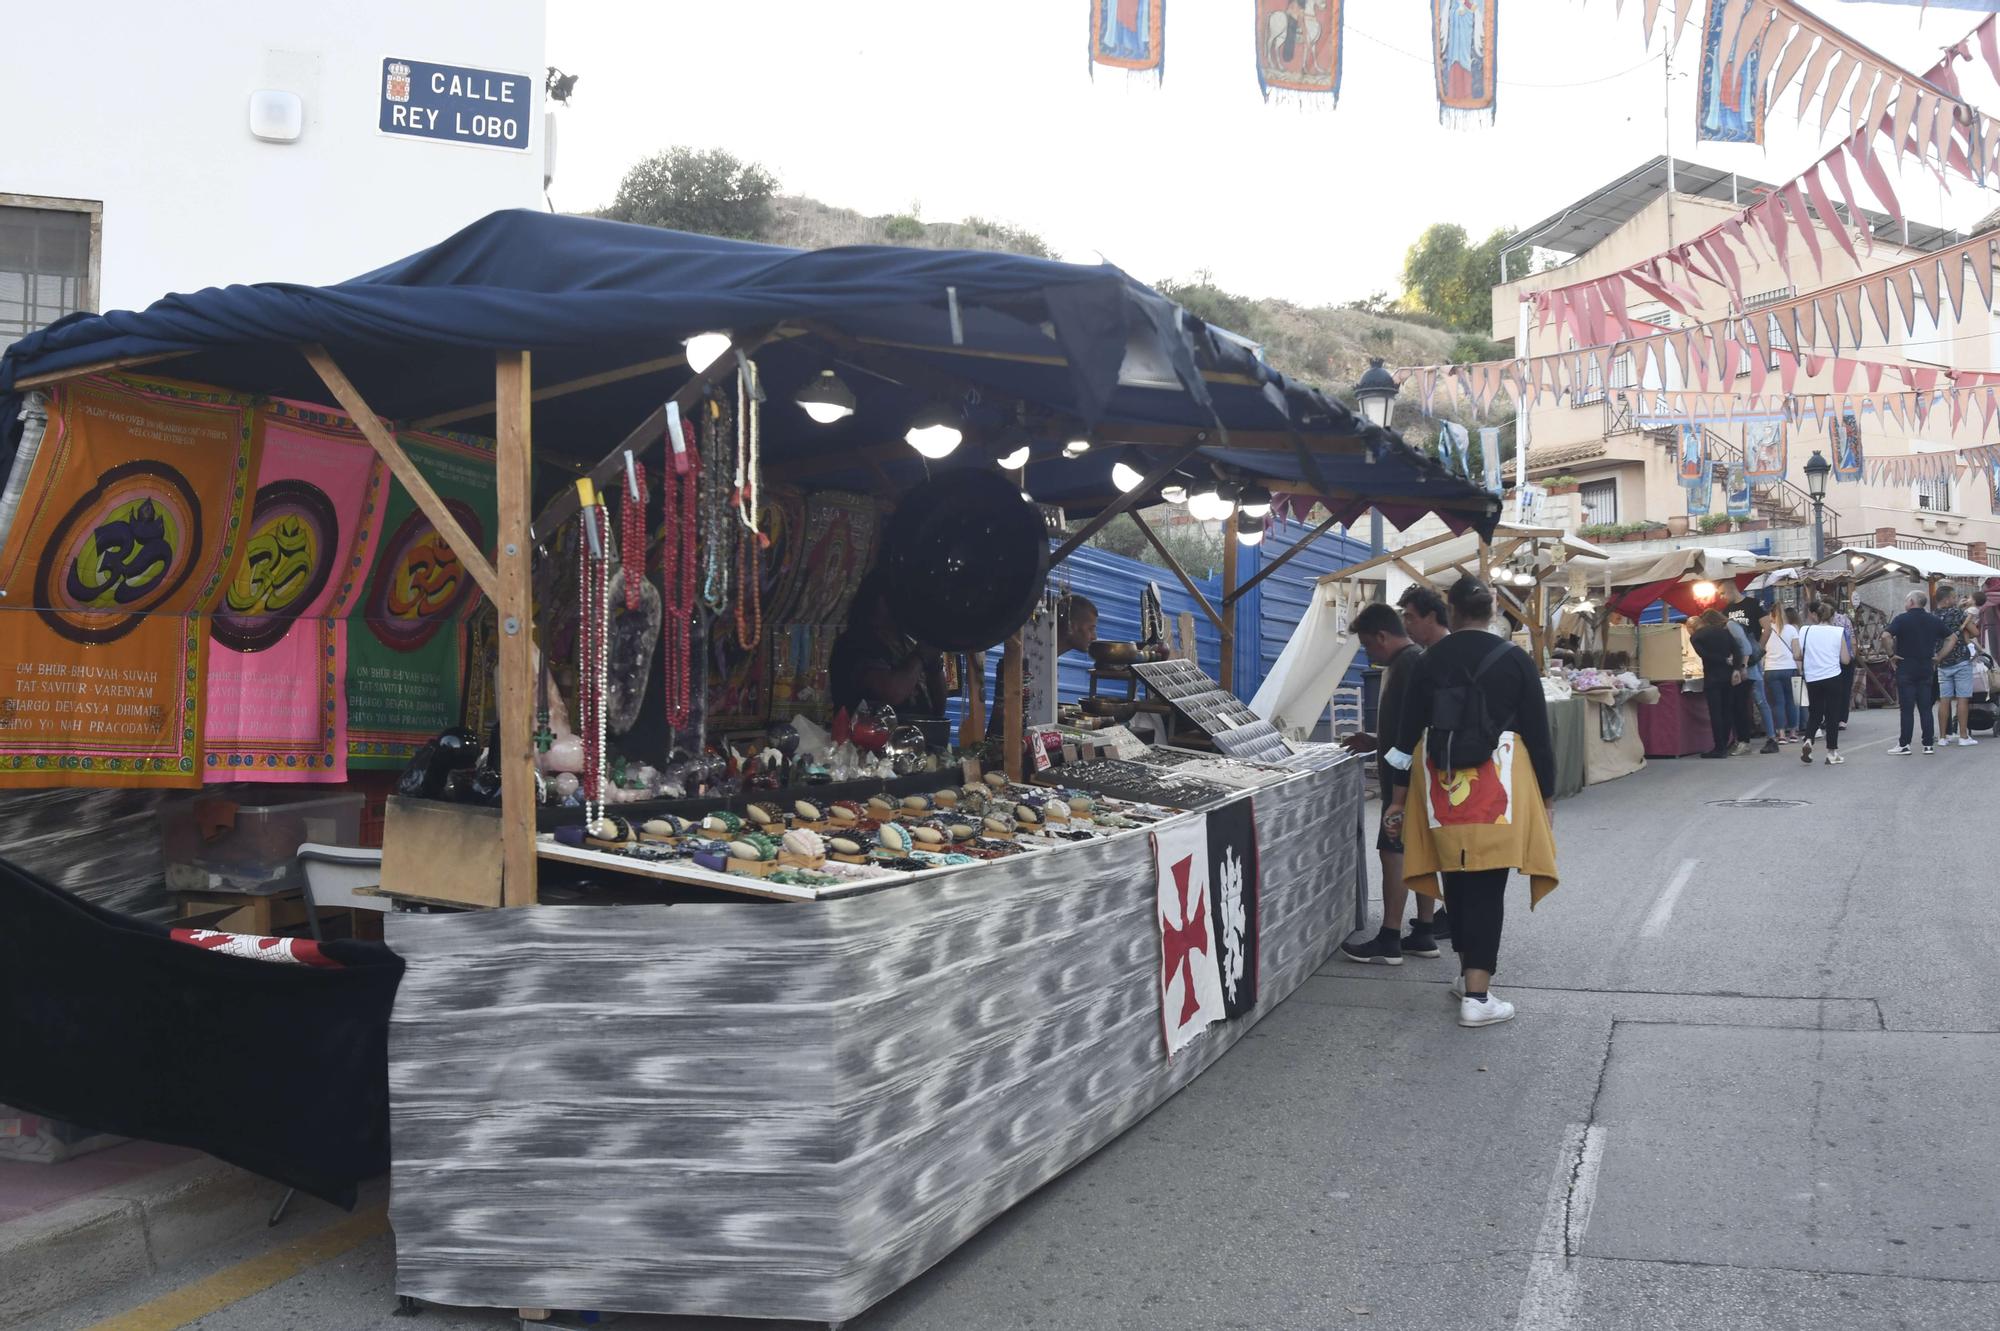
[0, 376, 262, 785]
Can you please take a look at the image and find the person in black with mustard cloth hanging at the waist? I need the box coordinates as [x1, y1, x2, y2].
[1388, 578, 1556, 1027]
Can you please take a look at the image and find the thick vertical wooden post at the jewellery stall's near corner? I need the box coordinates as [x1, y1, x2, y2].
[494, 352, 536, 905]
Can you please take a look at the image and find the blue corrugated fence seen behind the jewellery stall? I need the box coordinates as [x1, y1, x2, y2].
[952, 522, 1368, 717]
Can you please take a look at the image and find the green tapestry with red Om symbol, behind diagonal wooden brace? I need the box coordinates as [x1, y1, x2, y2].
[348, 434, 498, 771]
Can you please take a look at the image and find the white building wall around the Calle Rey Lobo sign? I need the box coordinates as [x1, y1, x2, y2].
[0, 0, 546, 310]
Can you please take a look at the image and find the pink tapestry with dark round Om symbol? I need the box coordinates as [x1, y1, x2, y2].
[202, 400, 388, 781]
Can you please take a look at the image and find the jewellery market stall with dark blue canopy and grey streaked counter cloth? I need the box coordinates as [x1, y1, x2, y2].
[0, 214, 1496, 1321]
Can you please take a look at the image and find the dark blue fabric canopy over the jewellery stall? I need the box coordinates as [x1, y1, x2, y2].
[0, 212, 1498, 530]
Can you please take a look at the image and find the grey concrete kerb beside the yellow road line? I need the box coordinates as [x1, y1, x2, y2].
[0, 1159, 284, 1327]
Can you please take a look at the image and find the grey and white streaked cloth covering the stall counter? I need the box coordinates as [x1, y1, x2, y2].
[388, 747, 1364, 1323]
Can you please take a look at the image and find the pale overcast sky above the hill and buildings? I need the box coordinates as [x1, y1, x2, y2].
[548, 0, 2000, 304]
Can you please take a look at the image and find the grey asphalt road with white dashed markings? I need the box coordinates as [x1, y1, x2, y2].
[32, 699, 2000, 1331]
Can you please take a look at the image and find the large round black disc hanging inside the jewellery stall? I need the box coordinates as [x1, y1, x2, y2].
[882, 468, 1048, 652]
